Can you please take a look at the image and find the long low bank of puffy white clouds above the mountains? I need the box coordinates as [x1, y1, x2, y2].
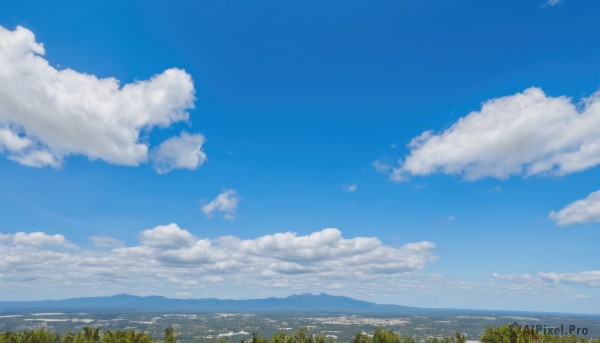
[0, 224, 436, 294]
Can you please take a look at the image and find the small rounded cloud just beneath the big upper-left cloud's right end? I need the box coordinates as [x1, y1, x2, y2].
[152, 132, 206, 174]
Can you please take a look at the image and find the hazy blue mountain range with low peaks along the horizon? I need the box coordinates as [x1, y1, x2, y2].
[0, 294, 421, 313]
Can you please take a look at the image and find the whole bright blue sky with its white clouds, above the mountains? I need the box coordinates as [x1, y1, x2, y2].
[0, 0, 600, 313]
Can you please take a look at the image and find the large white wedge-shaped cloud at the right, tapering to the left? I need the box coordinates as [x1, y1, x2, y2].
[392, 88, 600, 181]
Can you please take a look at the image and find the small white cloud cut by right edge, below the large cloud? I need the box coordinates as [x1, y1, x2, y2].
[548, 191, 600, 226]
